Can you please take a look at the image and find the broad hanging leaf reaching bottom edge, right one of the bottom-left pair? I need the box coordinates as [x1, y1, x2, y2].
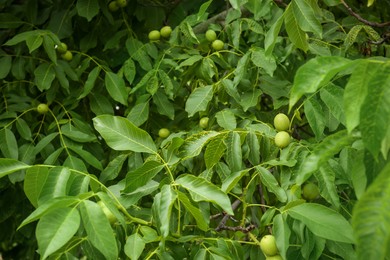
[80, 200, 118, 260]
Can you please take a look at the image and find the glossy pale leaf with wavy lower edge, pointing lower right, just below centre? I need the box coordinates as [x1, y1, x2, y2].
[175, 174, 234, 215]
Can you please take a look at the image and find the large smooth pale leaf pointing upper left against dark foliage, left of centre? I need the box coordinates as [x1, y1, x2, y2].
[93, 115, 157, 154]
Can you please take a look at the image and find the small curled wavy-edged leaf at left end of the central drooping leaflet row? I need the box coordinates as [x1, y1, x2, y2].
[181, 131, 219, 159]
